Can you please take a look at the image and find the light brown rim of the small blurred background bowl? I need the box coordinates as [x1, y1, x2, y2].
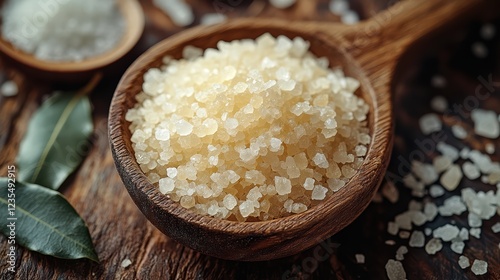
[0, 0, 145, 73]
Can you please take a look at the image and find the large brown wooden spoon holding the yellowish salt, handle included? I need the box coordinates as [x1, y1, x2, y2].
[109, 0, 483, 261]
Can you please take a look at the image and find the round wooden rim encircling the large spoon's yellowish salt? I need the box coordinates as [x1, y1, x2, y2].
[108, 19, 392, 235]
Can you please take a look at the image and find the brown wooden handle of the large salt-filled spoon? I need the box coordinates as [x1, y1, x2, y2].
[343, 0, 487, 69]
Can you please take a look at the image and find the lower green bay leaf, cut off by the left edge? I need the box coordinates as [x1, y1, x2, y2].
[0, 177, 99, 262]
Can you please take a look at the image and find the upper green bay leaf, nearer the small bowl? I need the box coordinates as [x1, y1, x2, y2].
[17, 92, 93, 190]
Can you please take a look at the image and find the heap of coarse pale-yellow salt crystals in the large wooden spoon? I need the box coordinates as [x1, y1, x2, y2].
[126, 34, 371, 221]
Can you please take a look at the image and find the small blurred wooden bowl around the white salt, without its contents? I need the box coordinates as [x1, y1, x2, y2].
[0, 0, 144, 82]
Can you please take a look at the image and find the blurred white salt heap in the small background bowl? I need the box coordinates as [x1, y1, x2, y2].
[1, 0, 126, 61]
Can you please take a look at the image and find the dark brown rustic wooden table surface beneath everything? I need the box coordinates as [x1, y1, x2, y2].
[0, 0, 500, 279]
